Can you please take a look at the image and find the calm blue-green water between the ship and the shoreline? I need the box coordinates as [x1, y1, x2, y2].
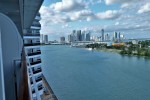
[41, 45, 150, 100]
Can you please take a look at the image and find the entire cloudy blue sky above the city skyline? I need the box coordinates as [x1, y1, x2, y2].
[40, 0, 150, 40]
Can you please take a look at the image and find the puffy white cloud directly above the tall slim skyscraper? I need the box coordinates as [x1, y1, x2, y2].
[96, 10, 121, 19]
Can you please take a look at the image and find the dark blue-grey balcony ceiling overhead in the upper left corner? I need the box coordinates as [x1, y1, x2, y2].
[0, 0, 43, 35]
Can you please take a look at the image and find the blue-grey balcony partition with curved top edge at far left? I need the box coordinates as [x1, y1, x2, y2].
[0, 13, 23, 100]
